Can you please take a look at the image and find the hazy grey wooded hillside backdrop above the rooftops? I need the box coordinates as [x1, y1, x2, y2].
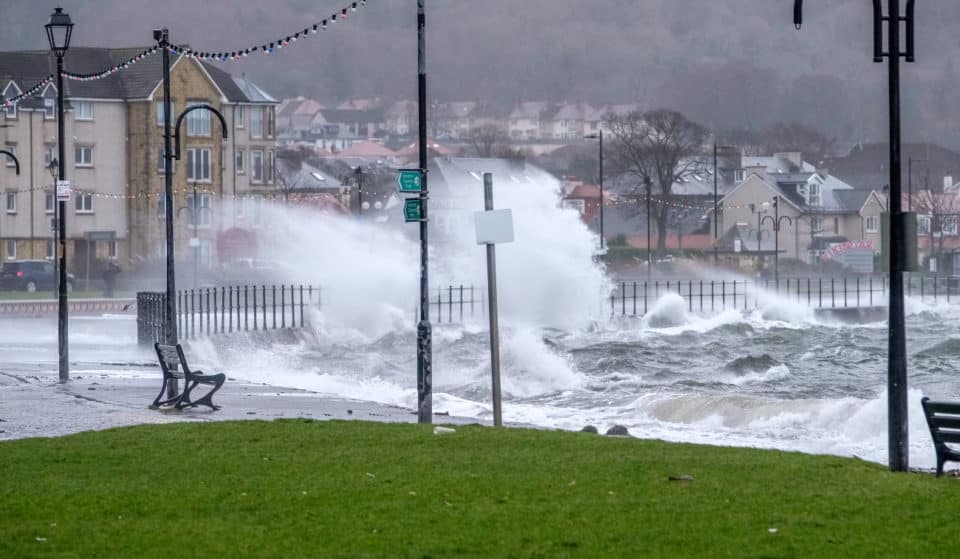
[0, 0, 960, 151]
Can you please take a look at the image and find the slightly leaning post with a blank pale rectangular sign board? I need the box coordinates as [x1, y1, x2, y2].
[475, 173, 513, 427]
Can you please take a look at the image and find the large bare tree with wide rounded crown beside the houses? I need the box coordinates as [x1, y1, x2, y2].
[608, 109, 707, 253]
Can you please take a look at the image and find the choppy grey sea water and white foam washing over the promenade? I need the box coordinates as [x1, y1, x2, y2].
[0, 295, 960, 467]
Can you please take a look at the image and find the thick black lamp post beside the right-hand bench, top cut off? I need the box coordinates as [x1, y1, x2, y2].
[793, 0, 916, 472]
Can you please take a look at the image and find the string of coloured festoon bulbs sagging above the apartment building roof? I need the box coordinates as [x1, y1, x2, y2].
[3, 0, 367, 107]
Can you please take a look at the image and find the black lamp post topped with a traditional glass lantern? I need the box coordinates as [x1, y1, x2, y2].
[44, 8, 73, 382]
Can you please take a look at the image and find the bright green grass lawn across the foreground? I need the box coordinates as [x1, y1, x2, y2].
[0, 420, 960, 558]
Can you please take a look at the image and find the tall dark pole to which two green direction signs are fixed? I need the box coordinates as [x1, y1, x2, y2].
[417, 0, 433, 423]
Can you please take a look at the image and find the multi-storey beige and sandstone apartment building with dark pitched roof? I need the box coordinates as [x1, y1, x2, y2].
[0, 47, 277, 277]
